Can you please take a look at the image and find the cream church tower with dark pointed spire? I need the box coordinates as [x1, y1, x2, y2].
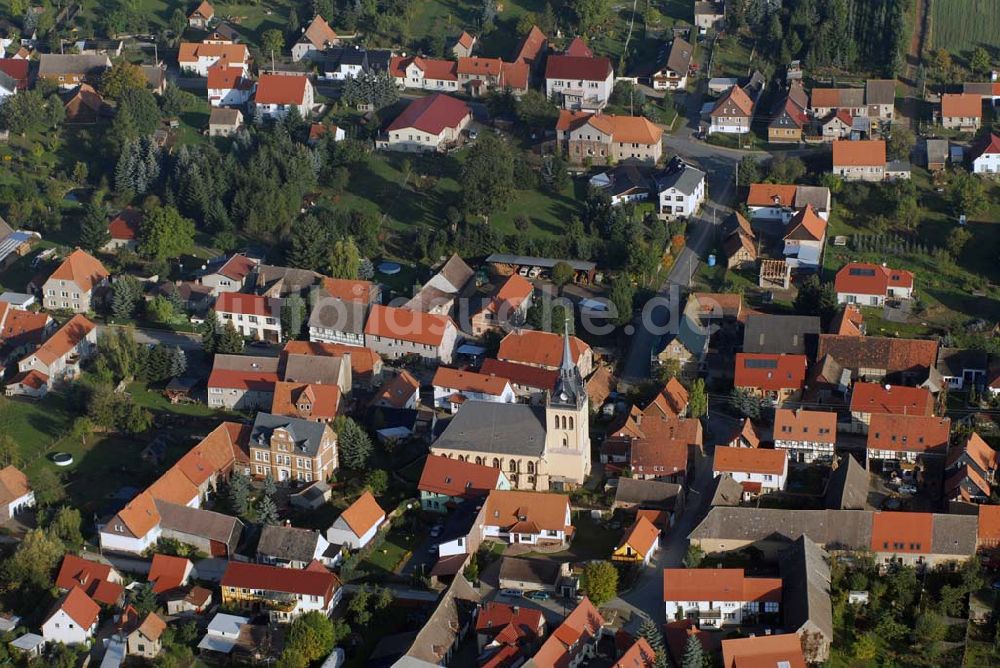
[543, 327, 590, 487]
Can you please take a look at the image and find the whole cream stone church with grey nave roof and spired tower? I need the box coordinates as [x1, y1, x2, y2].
[431, 334, 590, 491]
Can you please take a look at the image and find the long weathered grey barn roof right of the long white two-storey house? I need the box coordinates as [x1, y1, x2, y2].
[779, 536, 833, 642]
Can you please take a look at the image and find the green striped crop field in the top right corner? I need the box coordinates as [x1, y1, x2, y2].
[930, 0, 1000, 55]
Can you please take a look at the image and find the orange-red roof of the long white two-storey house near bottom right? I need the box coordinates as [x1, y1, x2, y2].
[663, 568, 781, 602]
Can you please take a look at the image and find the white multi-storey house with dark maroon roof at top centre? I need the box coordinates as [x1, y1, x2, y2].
[545, 55, 615, 111]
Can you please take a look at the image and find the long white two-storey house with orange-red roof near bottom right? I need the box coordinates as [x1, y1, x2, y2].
[663, 568, 781, 629]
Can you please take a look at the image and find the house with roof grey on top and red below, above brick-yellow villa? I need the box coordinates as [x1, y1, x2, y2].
[208, 353, 279, 411]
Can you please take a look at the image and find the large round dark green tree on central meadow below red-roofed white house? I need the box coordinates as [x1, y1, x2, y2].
[460, 133, 514, 215]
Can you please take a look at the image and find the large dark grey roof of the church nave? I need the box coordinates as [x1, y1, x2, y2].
[432, 401, 545, 457]
